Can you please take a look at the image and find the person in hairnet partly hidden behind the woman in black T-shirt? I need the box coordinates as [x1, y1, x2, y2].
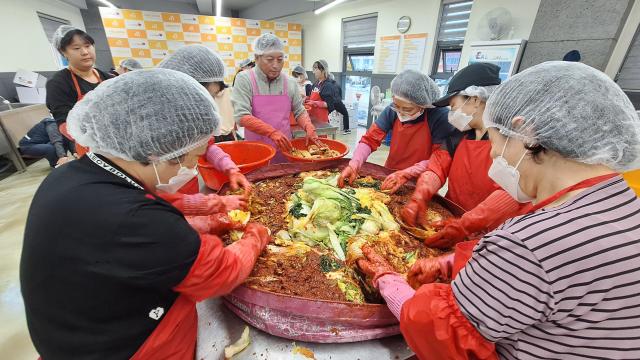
[158, 44, 251, 202]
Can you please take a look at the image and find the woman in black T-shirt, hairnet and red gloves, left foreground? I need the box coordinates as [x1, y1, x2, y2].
[20, 69, 270, 359]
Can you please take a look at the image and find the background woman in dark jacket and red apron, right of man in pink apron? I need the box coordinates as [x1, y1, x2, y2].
[305, 60, 351, 134]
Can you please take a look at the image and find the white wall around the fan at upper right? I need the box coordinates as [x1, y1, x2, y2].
[460, 0, 540, 68]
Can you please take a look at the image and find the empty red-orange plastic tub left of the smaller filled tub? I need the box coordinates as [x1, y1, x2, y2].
[198, 141, 276, 191]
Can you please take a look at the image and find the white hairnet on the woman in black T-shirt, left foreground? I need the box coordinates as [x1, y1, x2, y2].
[67, 69, 219, 162]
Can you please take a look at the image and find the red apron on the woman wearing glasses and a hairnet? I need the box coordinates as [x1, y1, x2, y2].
[384, 116, 432, 170]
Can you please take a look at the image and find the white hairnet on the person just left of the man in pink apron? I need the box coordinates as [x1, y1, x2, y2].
[158, 44, 225, 83]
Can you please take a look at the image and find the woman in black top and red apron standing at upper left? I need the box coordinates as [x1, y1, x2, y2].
[46, 25, 111, 147]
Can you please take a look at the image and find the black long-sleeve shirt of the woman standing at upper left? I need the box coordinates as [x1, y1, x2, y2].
[46, 68, 111, 125]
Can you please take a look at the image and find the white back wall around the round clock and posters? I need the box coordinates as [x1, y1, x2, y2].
[278, 0, 440, 72]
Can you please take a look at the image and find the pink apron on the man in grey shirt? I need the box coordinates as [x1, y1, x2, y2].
[244, 70, 291, 164]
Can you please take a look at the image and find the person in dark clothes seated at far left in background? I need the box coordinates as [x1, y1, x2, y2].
[18, 118, 75, 167]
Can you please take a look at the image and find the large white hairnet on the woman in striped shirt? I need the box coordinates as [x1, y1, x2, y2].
[483, 61, 640, 171]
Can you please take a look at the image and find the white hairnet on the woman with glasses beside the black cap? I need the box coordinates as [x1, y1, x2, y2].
[391, 70, 440, 106]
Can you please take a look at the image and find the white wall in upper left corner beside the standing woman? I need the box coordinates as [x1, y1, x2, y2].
[0, 0, 84, 72]
